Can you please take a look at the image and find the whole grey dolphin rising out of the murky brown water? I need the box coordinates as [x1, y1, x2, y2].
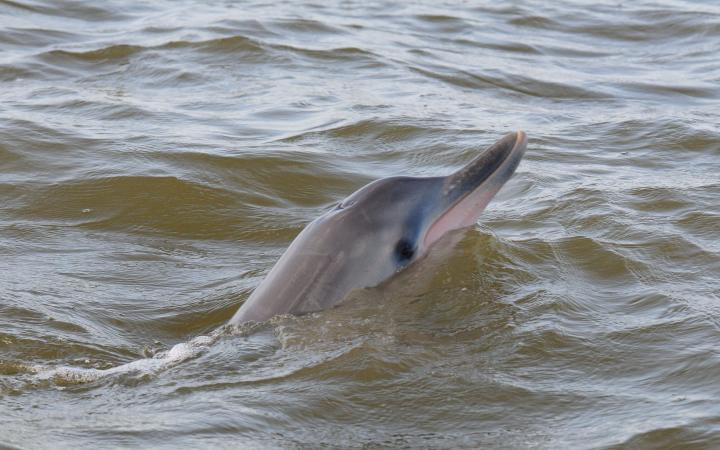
[230, 131, 527, 325]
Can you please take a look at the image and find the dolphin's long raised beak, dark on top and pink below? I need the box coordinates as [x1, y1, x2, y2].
[424, 130, 527, 247]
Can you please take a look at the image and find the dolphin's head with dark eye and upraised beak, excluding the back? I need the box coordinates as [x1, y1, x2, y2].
[324, 131, 527, 270]
